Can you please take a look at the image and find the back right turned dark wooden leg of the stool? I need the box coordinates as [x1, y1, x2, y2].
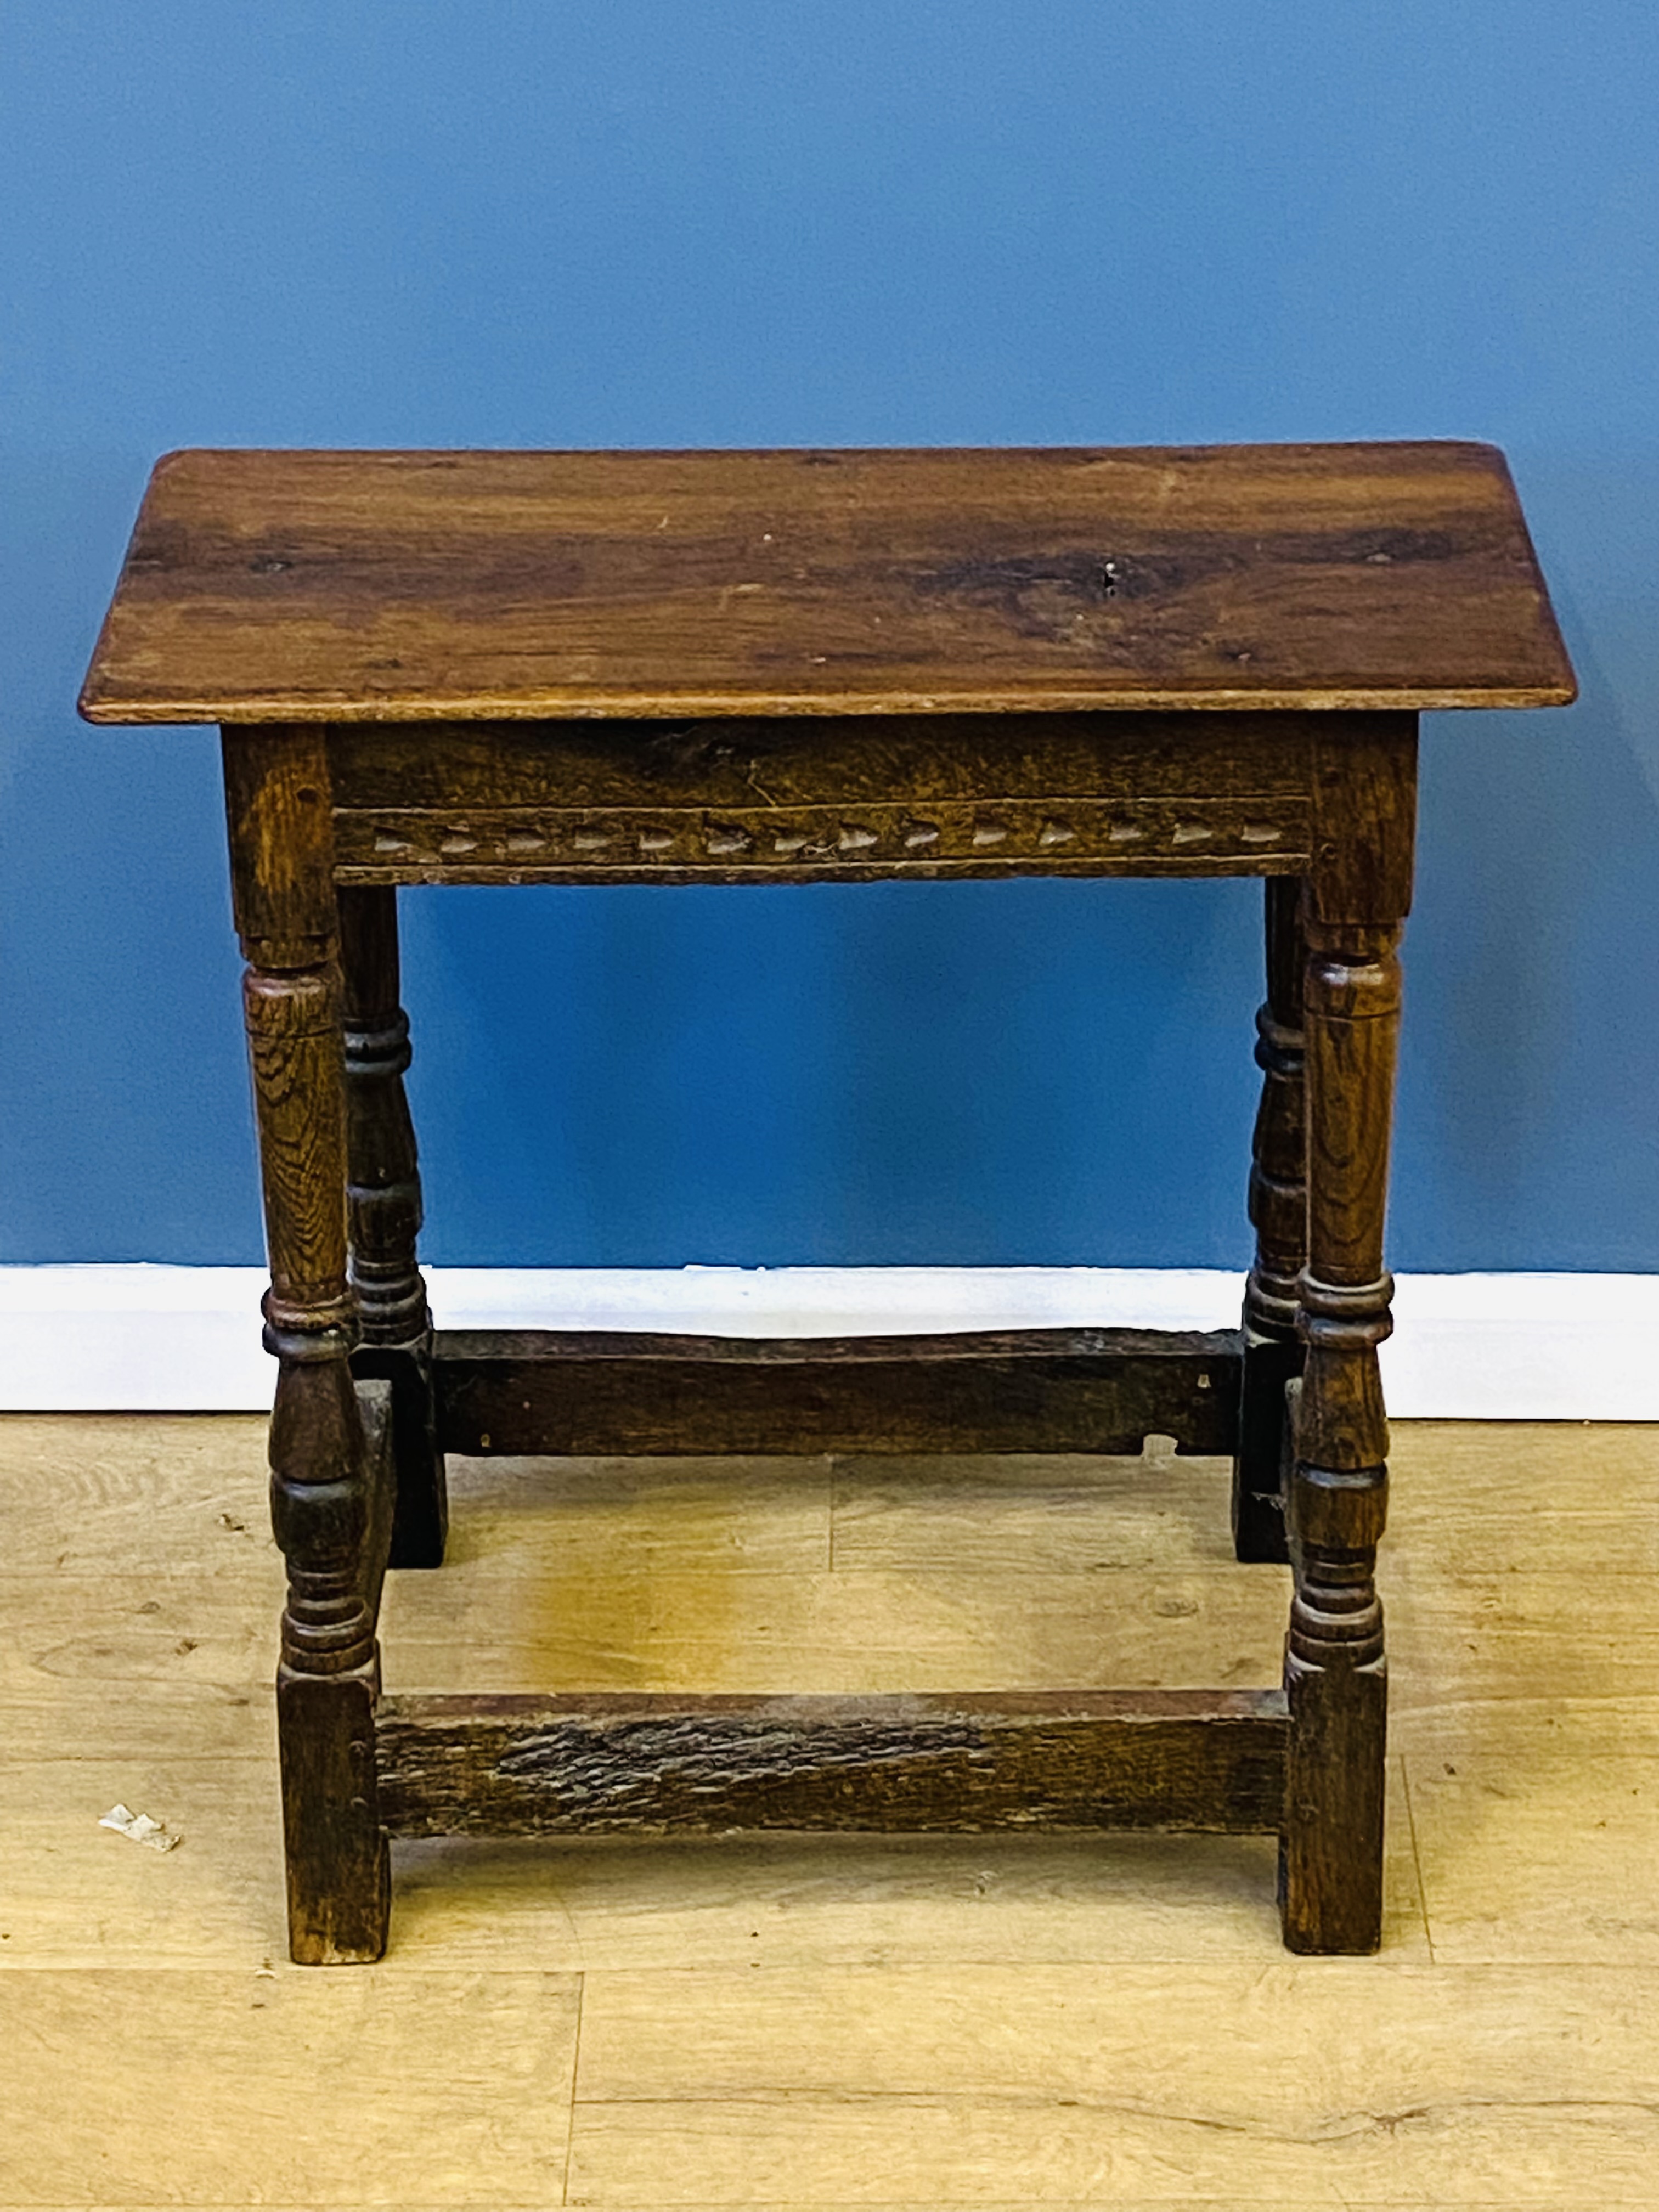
[1232, 876, 1307, 1562]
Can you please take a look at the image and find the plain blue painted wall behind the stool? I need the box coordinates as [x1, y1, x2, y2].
[0, 0, 1659, 1267]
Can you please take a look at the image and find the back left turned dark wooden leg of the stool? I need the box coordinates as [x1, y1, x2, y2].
[336, 885, 449, 1566]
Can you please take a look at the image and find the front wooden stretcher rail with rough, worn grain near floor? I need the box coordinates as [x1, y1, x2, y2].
[376, 1690, 1288, 1836]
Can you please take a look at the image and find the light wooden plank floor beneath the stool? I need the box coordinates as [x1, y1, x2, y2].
[0, 1415, 1659, 2212]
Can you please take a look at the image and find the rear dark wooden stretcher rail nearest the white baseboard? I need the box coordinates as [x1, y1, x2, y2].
[436, 1329, 1241, 1455]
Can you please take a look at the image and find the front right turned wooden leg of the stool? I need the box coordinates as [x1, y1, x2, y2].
[1283, 716, 1415, 1951]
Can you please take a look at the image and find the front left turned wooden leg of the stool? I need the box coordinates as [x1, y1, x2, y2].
[223, 728, 390, 1966]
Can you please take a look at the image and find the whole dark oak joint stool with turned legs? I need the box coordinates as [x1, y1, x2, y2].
[82, 442, 1573, 1964]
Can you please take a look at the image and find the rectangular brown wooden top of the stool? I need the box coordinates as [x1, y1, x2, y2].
[82, 442, 1575, 723]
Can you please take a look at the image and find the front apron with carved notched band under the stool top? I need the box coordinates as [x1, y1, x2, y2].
[332, 714, 1327, 883]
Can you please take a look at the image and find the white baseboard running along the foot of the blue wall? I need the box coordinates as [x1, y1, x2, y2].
[0, 1267, 1659, 1420]
